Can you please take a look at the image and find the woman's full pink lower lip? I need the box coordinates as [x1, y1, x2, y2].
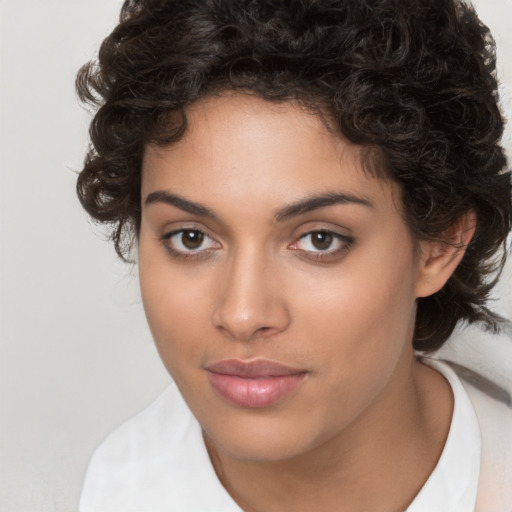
[208, 372, 306, 408]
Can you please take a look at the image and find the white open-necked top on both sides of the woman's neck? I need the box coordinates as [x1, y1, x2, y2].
[80, 361, 512, 512]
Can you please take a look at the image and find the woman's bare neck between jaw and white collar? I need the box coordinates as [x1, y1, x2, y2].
[205, 357, 453, 512]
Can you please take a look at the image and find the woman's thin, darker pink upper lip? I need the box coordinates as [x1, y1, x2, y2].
[206, 359, 306, 379]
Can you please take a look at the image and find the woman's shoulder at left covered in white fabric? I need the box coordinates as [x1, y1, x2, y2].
[80, 384, 242, 512]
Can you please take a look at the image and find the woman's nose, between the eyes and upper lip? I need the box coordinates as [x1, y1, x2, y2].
[213, 247, 290, 341]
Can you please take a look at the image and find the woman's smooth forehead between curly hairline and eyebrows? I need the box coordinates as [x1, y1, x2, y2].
[142, 93, 399, 216]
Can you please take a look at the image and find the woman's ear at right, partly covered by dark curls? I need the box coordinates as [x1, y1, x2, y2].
[416, 210, 476, 297]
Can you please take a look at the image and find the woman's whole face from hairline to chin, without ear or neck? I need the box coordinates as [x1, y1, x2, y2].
[139, 94, 424, 461]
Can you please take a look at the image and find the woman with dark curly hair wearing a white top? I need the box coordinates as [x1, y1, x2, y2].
[78, 0, 512, 512]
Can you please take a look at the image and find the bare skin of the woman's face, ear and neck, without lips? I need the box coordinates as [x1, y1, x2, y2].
[139, 93, 474, 512]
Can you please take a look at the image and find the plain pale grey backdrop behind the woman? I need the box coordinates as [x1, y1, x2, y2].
[0, 0, 512, 512]
